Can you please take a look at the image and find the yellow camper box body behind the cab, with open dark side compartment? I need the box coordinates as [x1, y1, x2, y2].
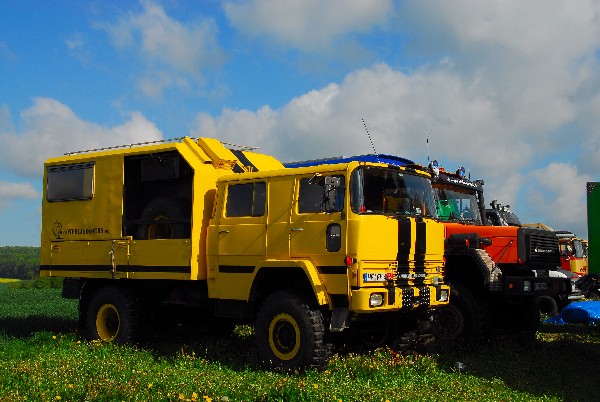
[40, 138, 282, 280]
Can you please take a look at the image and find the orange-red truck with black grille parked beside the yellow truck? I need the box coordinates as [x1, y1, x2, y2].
[429, 161, 572, 341]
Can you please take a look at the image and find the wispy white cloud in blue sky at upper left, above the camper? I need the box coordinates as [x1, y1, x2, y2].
[101, 0, 225, 97]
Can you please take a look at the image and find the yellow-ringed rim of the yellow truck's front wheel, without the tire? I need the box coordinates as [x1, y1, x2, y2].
[269, 313, 301, 360]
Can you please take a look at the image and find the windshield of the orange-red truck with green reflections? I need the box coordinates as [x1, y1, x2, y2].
[435, 187, 482, 225]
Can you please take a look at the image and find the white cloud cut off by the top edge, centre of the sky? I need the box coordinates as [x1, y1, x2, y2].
[224, 0, 393, 50]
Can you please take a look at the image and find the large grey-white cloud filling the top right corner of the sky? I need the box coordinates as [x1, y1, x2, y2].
[398, 0, 600, 134]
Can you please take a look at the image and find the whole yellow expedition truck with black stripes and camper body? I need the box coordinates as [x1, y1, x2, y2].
[41, 137, 449, 369]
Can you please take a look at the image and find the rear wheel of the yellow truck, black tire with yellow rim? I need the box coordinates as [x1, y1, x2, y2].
[84, 287, 138, 343]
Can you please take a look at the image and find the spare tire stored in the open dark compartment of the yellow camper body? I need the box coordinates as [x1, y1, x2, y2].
[136, 198, 185, 240]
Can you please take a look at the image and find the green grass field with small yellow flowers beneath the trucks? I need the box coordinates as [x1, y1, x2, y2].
[0, 286, 600, 401]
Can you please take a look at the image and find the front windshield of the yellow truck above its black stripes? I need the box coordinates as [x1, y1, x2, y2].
[350, 167, 437, 218]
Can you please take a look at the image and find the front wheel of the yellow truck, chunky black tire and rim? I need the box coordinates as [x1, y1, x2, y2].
[255, 291, 331, 371]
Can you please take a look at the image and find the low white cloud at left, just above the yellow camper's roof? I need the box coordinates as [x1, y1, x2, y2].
[0, 98, 162, 177]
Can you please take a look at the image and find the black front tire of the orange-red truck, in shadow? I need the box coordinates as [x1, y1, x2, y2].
[431, 284, 490, 343]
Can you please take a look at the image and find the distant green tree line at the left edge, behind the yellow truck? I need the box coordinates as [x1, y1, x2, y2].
[0, 246, 40, 279]
